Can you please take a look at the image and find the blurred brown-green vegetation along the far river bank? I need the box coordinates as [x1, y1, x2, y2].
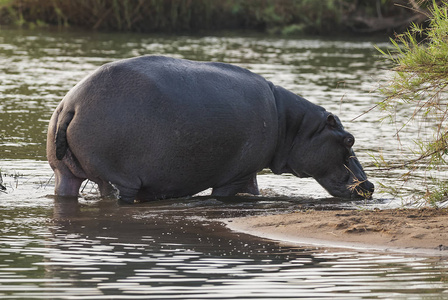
[0, 0, 434, 35]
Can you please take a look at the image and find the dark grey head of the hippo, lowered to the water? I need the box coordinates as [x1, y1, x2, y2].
[287, 112, 374, 199]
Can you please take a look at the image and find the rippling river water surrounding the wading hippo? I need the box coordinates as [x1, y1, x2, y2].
[0, 28, 448, 299]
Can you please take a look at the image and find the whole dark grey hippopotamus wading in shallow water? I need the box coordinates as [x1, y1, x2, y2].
[47, 56, 374, 203]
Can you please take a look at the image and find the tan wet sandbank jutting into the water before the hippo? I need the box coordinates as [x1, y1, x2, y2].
[224, 208, 448, 256]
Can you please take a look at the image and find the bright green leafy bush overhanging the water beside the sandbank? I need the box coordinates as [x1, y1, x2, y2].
[379, 2, 448, 204]
